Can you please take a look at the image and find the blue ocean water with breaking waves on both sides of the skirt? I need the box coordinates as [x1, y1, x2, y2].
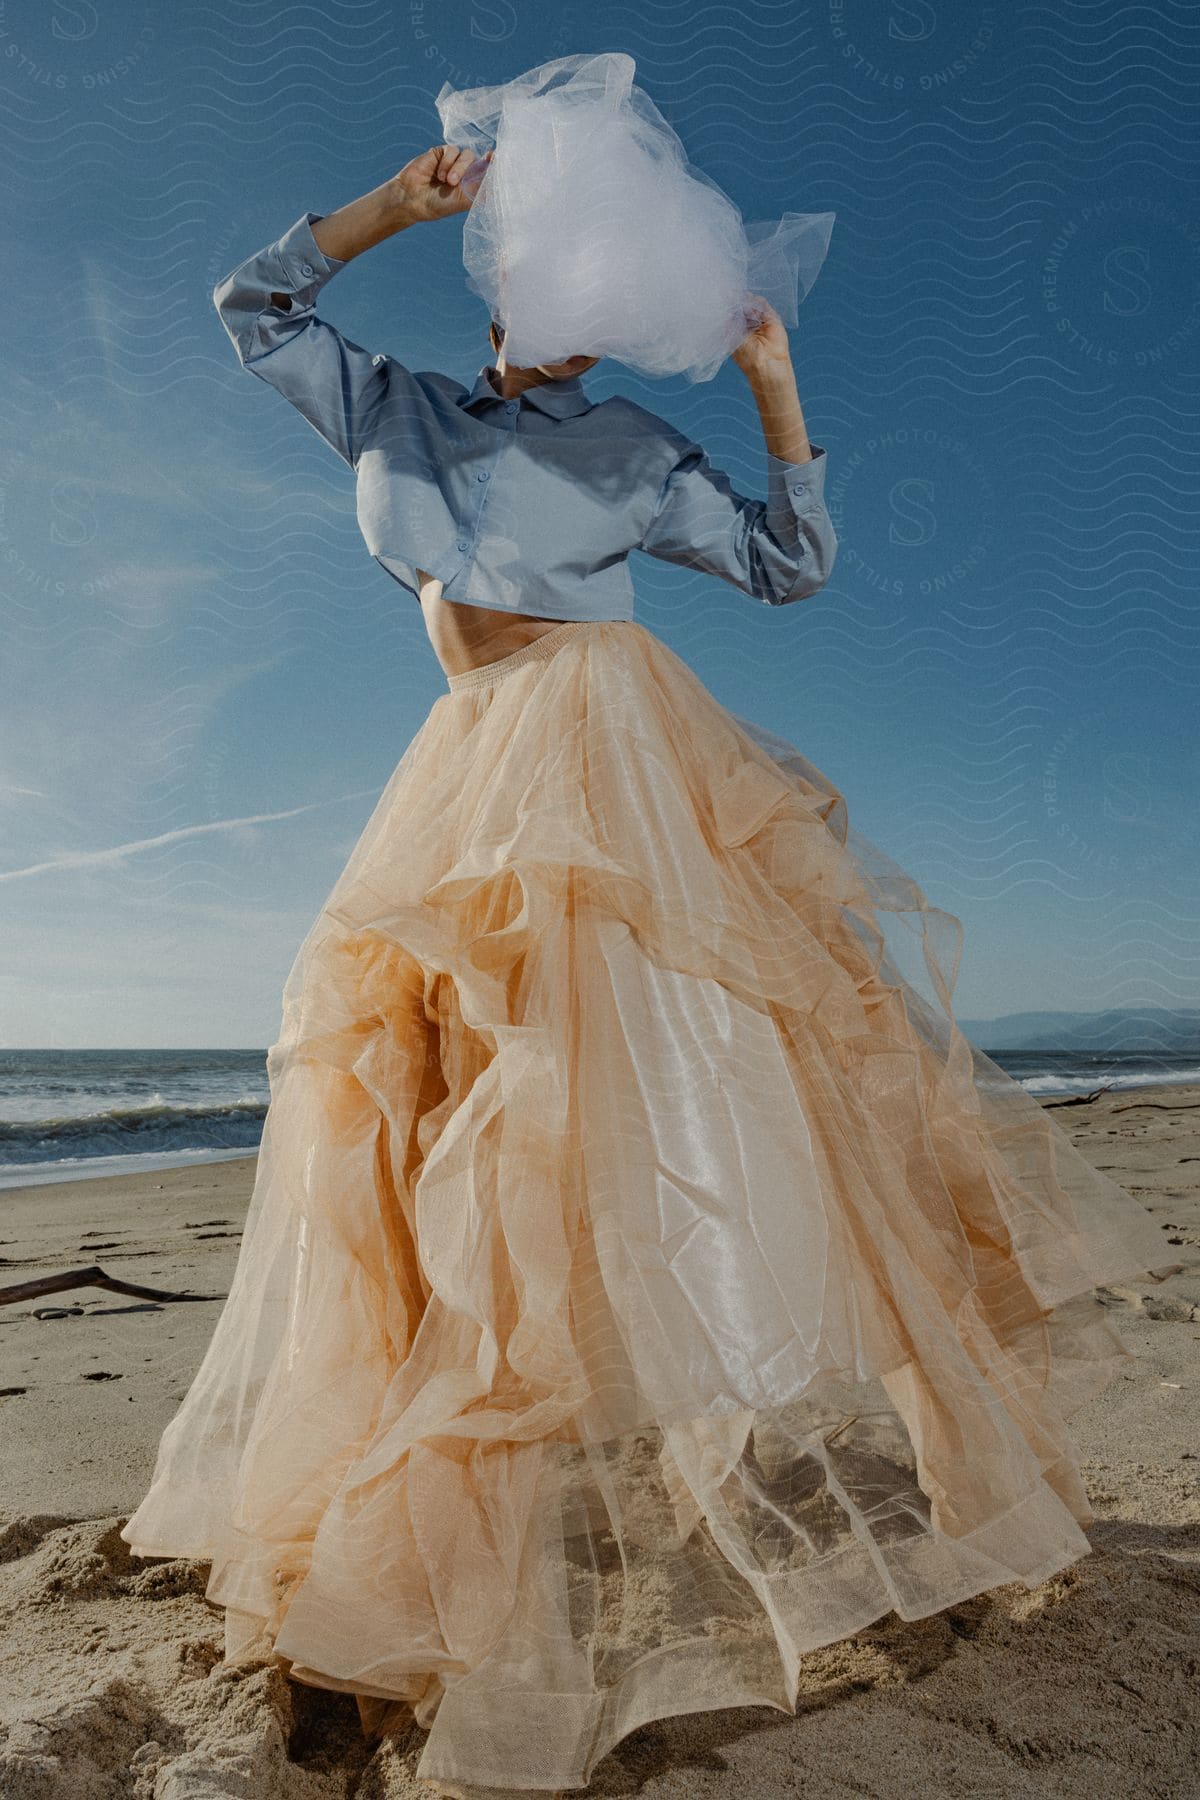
[0, 1049, 1200, 1188]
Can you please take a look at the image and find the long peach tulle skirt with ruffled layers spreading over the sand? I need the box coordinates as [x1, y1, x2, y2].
[121, 621, 1164, 1787]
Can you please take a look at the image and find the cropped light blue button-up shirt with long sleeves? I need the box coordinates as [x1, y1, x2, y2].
[212, 212, 837, 619]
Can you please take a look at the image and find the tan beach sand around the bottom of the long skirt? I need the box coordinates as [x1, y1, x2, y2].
[0, 1087, 1200, 1800]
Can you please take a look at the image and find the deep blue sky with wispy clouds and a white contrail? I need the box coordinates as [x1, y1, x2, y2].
[0, 0, 1200, 1048]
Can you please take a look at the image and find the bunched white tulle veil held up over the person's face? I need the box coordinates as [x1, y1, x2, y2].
[437, 52, 835, 382]
